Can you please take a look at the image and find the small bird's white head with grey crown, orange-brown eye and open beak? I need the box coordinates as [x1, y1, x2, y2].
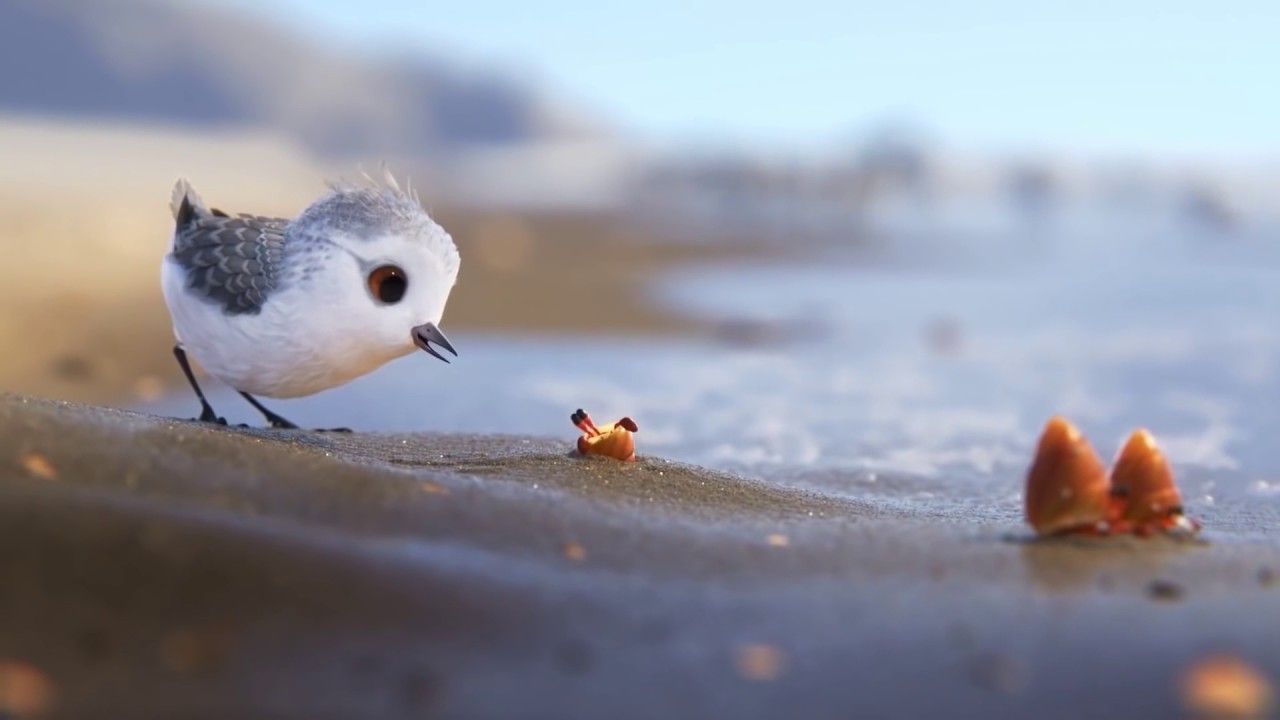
[289, 176, 460, 363]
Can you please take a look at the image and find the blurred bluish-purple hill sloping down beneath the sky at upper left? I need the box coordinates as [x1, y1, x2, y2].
[0, 0, 582, 158]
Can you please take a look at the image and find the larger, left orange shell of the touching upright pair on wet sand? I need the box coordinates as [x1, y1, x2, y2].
[1027, 416, 1111, 536]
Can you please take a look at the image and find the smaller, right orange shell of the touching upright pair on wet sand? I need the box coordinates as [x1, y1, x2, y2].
[1111, 429, 1183, 527]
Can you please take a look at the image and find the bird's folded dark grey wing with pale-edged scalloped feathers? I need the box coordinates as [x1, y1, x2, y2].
[173, 210, 289, 315]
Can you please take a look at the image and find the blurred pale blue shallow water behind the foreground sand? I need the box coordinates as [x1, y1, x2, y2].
[140, 221, 1280, 536]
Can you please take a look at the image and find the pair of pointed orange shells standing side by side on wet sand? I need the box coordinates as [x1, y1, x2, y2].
[1027, 418, 1199, 536]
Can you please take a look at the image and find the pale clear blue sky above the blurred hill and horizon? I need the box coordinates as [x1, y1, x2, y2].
[214, 0, 1280, 156]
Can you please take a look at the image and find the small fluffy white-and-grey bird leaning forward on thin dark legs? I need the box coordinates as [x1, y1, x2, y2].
[160, 173, 461, 429]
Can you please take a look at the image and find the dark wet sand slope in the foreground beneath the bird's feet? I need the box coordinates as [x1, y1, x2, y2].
[0, 396, 1280, 719]
